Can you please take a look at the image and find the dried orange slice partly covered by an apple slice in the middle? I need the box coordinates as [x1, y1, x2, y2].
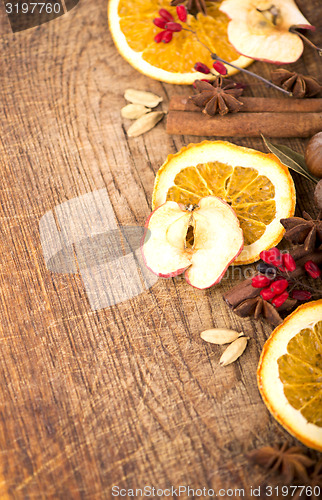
[152, 141, 295, 265]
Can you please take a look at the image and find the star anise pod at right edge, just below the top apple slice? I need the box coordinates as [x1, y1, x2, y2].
[271, 68, 322, 98]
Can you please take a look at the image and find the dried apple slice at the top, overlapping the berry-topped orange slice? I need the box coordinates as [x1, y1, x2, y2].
[220, 0, 310, 64]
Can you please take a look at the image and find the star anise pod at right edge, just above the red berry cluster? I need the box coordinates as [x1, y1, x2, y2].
[281, 212, 322, 252]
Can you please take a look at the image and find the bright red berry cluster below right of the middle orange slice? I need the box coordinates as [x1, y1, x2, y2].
[252, 248, 321, 308]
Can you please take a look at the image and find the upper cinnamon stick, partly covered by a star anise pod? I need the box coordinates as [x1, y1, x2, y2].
[169, 95, 322, 113]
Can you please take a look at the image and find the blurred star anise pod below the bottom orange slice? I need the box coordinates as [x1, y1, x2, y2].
[248, 443, 314, 484]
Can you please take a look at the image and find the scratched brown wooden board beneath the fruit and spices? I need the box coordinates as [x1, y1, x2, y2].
[0, 0, 322, 500]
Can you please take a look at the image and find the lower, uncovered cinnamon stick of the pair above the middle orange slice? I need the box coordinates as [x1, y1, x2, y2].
[167, 111, 322, 137]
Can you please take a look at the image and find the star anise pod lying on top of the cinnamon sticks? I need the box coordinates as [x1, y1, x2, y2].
[190, 76, 244, 116]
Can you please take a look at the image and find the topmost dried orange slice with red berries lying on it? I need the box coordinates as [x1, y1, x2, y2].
[108, 0, 252, 84]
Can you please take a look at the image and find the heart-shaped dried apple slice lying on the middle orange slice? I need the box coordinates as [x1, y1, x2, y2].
[142, 196, 244, 289]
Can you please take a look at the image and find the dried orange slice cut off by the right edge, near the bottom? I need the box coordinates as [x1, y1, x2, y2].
[257, 299, 322, 451]
